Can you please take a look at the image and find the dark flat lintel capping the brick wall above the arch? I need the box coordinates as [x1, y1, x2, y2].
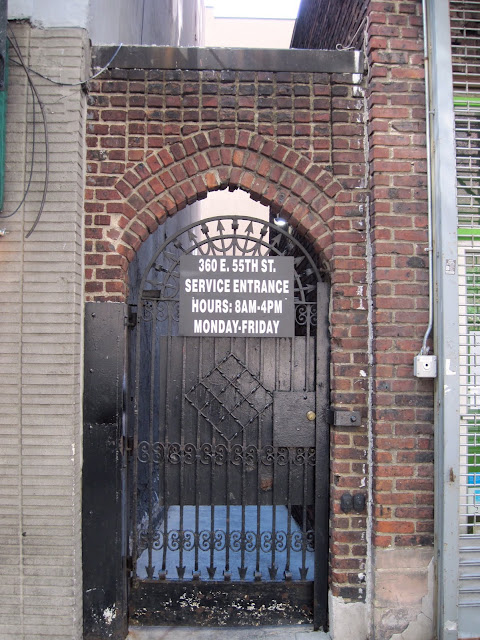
[92, 45, 363, 73]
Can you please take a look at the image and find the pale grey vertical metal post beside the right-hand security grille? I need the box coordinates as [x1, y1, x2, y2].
[425, 0, 460, 640]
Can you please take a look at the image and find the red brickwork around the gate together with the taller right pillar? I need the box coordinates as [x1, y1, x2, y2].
[85, 2, 433, 624]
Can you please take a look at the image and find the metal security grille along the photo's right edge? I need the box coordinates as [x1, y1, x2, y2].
[450, 0, 480, 633]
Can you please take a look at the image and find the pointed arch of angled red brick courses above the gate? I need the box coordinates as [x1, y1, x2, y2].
[115, 130, 342, 258]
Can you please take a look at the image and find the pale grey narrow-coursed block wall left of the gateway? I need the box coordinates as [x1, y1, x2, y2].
[0, 22, 87, 640]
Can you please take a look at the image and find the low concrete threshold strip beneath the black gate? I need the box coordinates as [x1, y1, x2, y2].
[127, 625, 331, 640]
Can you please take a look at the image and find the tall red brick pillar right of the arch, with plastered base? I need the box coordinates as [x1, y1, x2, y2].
[367, 0, 433, 635]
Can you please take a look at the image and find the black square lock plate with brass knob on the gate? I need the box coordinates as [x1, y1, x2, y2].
[273, 391, 315, 447]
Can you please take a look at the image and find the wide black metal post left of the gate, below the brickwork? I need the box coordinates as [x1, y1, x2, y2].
[82, 302, 127, 640]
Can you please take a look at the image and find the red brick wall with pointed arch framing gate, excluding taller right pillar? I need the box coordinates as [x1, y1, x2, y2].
[85, 63, 368, 599]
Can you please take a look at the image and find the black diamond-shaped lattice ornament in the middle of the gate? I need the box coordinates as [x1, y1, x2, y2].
[185, 353, 273, 442]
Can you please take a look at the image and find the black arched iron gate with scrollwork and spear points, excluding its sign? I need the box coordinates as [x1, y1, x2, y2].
[129, 216, 329, 628]
